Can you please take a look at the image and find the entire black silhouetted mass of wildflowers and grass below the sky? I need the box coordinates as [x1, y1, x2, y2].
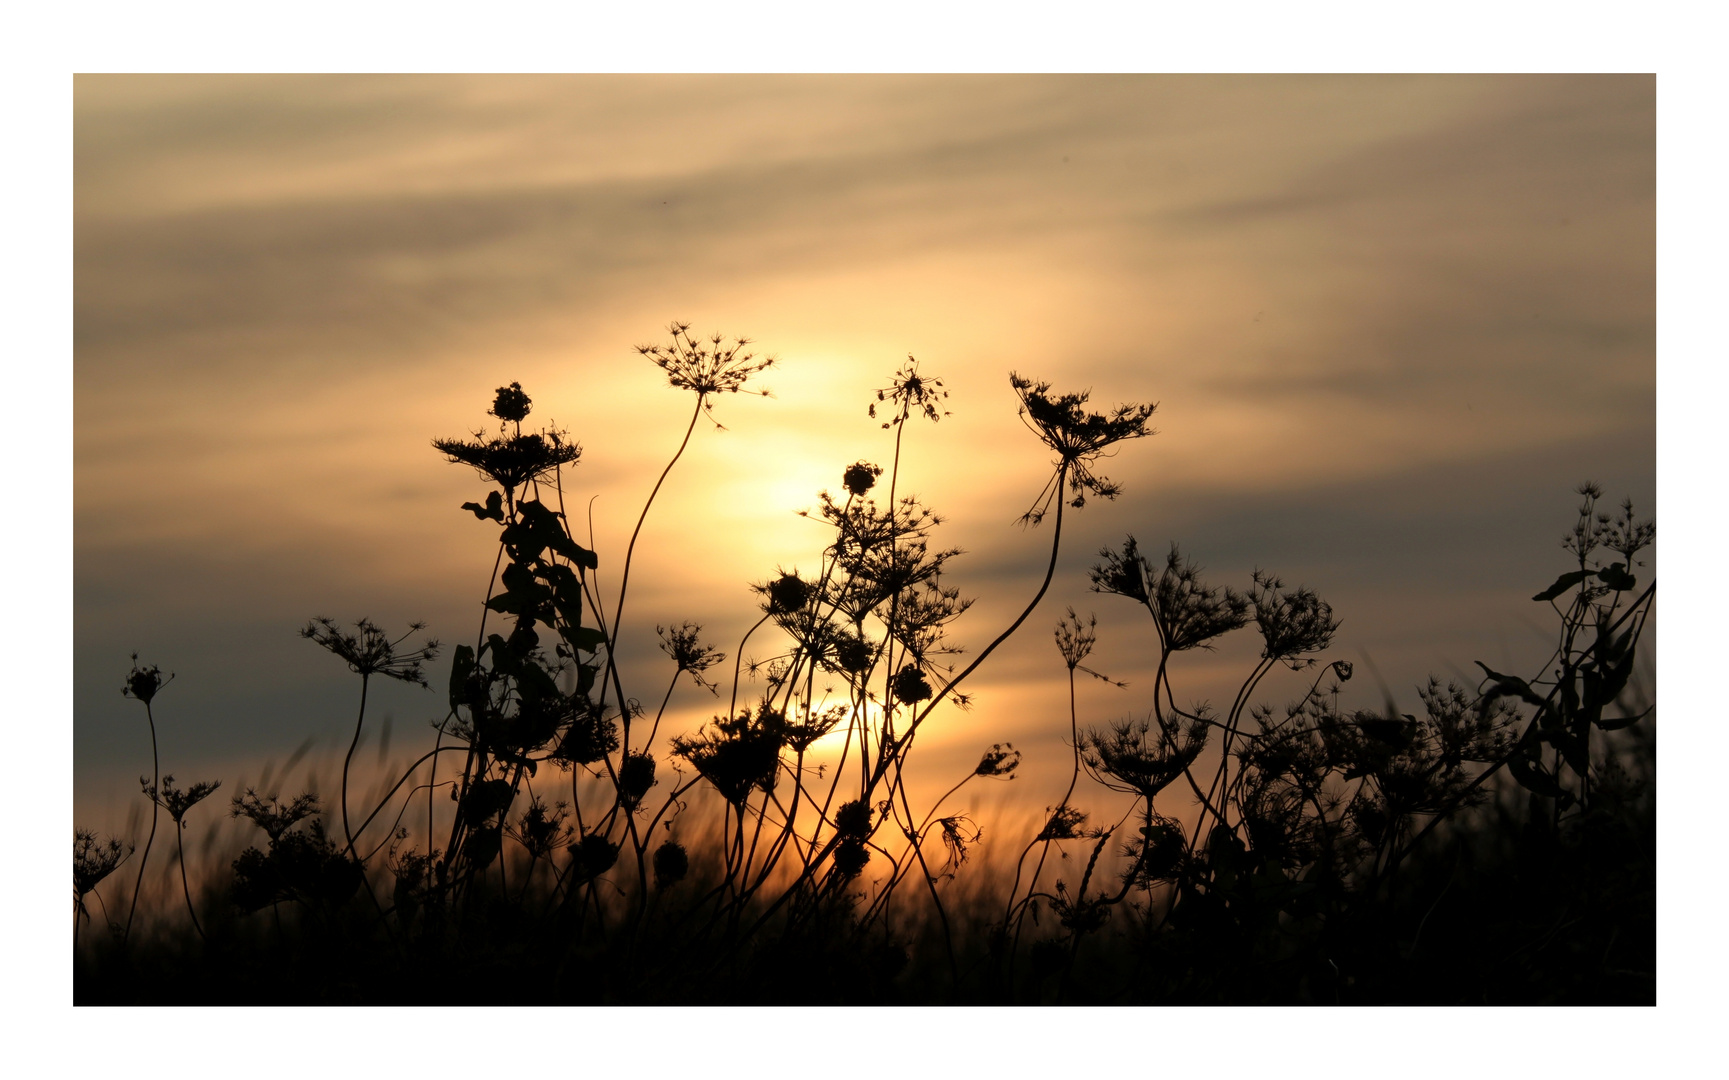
[74, 323, 1655, 1004]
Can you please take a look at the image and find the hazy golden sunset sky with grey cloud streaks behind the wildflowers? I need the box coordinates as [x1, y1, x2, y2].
[73, 76, 1656, 828]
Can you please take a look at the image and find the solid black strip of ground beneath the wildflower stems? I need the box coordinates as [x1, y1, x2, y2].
[74, 784, 1656, 1006]
